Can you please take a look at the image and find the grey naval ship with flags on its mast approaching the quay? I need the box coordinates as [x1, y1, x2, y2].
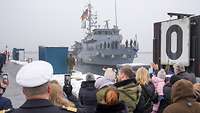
[72, 4, 139, 66]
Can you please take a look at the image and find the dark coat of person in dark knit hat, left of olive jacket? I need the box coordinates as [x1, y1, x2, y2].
[79, 81, 97, 106]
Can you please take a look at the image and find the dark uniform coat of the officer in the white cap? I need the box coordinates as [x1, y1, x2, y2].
[11, 99, 72, 113]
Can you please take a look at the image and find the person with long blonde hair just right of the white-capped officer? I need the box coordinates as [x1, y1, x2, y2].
[49, 80, 75, 108]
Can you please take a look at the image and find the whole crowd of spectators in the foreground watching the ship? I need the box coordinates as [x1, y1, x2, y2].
[0, 61, 200, 113]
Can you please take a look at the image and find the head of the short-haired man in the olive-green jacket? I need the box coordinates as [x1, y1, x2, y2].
[118, 65, 135, 81]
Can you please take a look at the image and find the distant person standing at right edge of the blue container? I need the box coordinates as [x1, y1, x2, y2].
[67, 54, 76, 74]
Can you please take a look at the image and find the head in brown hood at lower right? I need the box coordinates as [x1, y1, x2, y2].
[171, 79, 194, 102]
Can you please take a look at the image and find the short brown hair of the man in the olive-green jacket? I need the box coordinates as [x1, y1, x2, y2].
[120, 65, 135, 79]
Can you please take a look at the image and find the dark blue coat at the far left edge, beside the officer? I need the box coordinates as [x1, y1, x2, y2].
[0, 97, 12, 110]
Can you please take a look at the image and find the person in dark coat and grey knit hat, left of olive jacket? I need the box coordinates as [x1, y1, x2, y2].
[79, 73, 97, 113]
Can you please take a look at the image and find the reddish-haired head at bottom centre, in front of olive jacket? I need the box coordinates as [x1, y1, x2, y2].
[104, 87, 119, 105]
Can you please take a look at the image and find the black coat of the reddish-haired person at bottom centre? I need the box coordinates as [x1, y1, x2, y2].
[95, 102, 128, 113]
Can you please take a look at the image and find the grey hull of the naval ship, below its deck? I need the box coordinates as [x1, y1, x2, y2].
[77, 48, 137, 66]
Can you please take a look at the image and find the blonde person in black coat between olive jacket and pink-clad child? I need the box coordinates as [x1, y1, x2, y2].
[134, 67, 157, 113]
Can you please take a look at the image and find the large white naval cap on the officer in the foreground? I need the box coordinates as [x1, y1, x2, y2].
[16, 61, 53, 87]
